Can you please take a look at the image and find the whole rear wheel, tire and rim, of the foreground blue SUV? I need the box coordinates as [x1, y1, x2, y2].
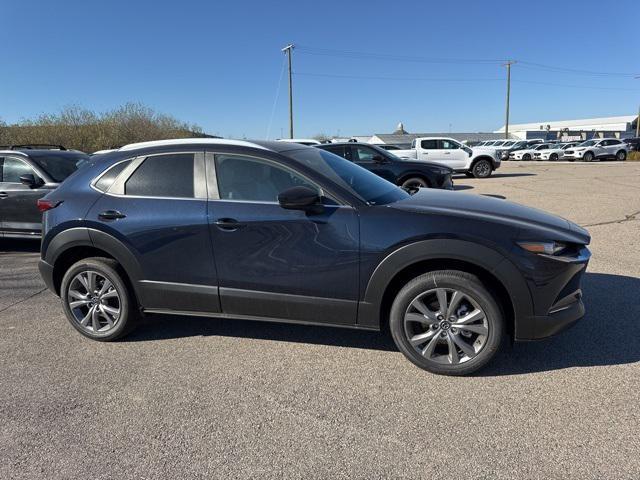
[60, 257, 136, 341]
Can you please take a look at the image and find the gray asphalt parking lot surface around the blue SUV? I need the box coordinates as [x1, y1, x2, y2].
[0, 162, 640, 479]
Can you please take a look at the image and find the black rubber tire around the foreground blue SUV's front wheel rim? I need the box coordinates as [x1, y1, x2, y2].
[389, 270, 504, 375]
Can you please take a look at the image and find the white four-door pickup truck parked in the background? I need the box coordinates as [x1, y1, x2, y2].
[391, 137, 500, 178]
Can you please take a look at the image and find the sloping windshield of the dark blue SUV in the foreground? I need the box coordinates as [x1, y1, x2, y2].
[286, 148, 409, 205]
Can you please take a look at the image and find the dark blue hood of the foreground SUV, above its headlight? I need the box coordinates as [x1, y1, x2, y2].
[389, 189, 591, 245]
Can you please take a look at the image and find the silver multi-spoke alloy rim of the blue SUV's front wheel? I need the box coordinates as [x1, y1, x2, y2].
[404, 288, 489, 365]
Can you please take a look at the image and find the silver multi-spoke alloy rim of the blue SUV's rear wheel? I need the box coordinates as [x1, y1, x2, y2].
[67, 270, 121, 335]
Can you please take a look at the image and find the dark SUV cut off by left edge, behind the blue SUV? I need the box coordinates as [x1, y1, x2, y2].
[0, 145, 89, 238]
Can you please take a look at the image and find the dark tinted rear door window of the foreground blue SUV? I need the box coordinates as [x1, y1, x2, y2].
[124, 153, 194, 198]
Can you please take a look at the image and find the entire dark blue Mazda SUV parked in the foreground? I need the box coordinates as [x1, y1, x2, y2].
[39, 139, 590, 375]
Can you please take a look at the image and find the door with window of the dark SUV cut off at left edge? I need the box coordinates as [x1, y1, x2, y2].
[0, 155, 51, 237]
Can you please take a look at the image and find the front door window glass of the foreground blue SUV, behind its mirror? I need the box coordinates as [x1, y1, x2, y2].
[215, 155, 322, 202]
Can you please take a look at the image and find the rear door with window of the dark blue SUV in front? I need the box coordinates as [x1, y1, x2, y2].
[87, 149, 220, 313]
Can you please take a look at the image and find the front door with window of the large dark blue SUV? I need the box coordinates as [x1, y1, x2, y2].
[207, 153, 359, 324]
